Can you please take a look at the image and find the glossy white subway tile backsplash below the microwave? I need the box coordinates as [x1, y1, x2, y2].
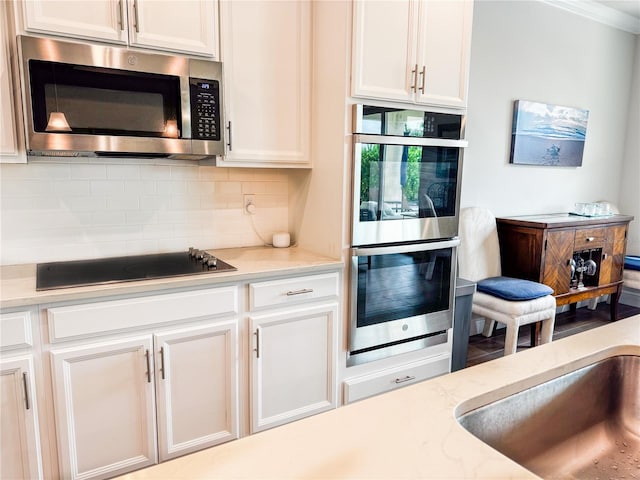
[0, 158, 289, 265]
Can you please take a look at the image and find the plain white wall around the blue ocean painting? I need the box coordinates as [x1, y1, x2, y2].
[461, 0, 640, 222]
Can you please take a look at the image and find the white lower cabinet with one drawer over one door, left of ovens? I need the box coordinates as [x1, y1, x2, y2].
[249, 272, 340, 432]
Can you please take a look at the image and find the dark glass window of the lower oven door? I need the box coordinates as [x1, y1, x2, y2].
[357, 248, 452, 327]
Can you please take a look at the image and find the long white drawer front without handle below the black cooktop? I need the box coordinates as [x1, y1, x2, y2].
[47, 286, 238, 342]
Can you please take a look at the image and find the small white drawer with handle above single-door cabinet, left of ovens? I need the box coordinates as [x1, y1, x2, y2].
[249, 273, 339, 310]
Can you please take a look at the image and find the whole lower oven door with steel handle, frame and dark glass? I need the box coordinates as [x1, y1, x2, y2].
[349, 238, 460, 355]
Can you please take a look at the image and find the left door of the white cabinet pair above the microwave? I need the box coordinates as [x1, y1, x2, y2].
[20, 0, 127, 44]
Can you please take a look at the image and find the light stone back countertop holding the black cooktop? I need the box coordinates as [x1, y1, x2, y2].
[0, 247, 343, 308]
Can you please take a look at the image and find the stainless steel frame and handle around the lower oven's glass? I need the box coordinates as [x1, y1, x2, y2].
[349, 237, 460, 355]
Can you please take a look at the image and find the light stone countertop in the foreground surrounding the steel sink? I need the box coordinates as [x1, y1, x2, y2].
[115, 315, 640, 480]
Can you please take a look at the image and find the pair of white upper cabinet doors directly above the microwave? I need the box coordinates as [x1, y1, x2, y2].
[22, 0, 219, 59]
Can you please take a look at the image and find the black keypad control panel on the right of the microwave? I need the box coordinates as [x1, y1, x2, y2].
[189, 78, 221, 141]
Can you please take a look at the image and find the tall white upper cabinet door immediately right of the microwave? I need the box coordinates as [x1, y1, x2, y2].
[218, 0, 311, 167]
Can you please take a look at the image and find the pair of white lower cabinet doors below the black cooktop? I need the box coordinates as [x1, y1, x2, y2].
[51, 321, 237, 479]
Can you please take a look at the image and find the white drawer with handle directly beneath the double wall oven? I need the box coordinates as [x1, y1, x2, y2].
[344, 353, 451, 403]
